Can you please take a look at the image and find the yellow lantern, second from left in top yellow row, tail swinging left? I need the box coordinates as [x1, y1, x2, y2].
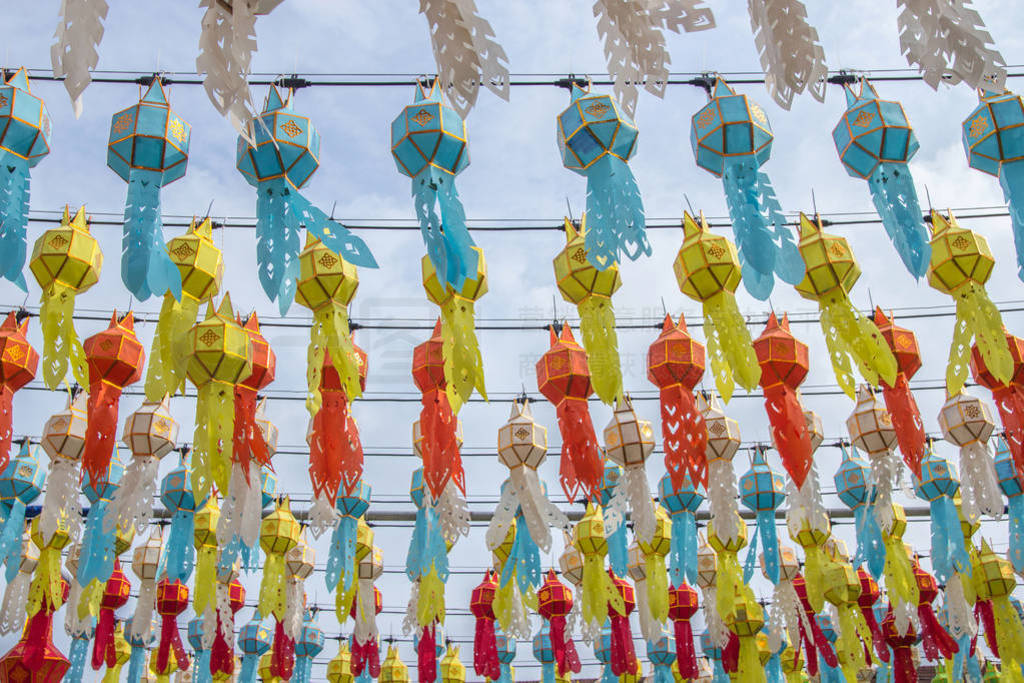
[145, 216, 224, 403]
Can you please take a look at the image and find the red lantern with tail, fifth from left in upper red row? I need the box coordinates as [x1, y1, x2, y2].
[413, 319, 466, 499]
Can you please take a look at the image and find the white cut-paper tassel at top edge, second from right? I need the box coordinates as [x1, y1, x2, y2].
[746, 0, 828, 110]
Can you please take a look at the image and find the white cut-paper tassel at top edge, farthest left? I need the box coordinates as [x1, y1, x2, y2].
[50, 0, 108, 118]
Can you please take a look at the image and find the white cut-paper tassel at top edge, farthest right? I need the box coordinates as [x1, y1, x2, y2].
[897, 0, 1007, 90]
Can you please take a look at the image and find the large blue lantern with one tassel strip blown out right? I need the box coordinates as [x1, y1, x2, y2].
[236, 85, 377, 315]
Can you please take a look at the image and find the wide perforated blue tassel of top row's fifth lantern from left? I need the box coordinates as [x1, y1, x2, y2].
[584, 154, 651, 270]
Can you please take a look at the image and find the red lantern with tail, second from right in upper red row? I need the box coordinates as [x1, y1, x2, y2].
[874, 308, 926, 479]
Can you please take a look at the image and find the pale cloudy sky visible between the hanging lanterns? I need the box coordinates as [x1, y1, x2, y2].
[0, 0, 1024, 678]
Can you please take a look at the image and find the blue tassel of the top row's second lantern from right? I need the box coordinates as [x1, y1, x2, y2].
[867, 162, 932, 278]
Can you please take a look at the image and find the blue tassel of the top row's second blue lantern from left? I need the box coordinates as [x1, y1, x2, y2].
[121, 168, 181, 301]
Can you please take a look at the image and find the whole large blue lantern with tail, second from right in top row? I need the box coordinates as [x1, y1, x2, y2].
[833, 78, 932, 278]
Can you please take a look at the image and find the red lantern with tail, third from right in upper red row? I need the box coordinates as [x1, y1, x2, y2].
[754, 312, 814, 487]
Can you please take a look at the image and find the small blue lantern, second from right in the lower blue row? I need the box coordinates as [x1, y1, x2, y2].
[914, 444, 971, 584]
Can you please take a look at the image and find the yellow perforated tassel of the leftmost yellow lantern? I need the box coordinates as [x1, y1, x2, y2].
[39, 283, 89, 390]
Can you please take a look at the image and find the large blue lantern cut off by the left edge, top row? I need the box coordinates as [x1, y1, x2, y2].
[0, 68, 50, 291]
